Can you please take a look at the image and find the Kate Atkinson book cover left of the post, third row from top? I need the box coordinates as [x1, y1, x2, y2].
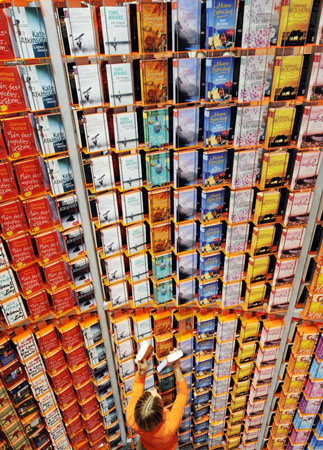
[34, 114, 67, 155]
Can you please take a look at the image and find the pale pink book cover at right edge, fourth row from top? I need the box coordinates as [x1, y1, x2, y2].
[290, 150, 322, 190]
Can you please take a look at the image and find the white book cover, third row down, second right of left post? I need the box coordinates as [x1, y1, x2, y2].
[113, 112, 138, 151]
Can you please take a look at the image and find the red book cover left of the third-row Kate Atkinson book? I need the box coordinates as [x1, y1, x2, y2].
[2, 116, 37, 159]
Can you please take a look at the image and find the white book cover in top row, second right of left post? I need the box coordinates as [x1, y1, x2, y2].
[100, 6, 130, 55]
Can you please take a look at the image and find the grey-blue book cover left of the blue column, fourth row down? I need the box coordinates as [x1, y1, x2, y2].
[173, 150, 198, 188]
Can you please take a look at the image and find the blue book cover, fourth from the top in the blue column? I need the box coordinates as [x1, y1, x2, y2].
[202, 150, 228, 187]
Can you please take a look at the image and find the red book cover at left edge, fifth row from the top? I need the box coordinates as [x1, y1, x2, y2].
[0, 199, 28, 236]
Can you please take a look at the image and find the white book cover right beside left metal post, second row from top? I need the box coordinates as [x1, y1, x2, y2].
[73, 64, 104, 108]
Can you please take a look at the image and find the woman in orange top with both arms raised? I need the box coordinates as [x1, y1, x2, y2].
[127, 361, 188, 450]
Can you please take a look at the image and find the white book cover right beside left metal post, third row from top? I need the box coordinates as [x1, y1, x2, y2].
[83, 113, 110, 152]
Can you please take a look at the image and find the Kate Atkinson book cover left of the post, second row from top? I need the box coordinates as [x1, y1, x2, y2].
[18, 64, 58, 111]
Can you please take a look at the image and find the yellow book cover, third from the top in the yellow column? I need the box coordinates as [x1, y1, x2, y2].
[264, 108, 296, 148]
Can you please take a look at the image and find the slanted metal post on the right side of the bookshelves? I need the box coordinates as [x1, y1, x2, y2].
[256, 163, 323, 450]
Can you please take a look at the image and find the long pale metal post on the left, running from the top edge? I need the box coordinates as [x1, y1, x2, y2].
[40, 0, 127, 444]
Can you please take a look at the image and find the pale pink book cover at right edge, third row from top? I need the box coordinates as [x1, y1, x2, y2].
[297, 106, 323, 148]
